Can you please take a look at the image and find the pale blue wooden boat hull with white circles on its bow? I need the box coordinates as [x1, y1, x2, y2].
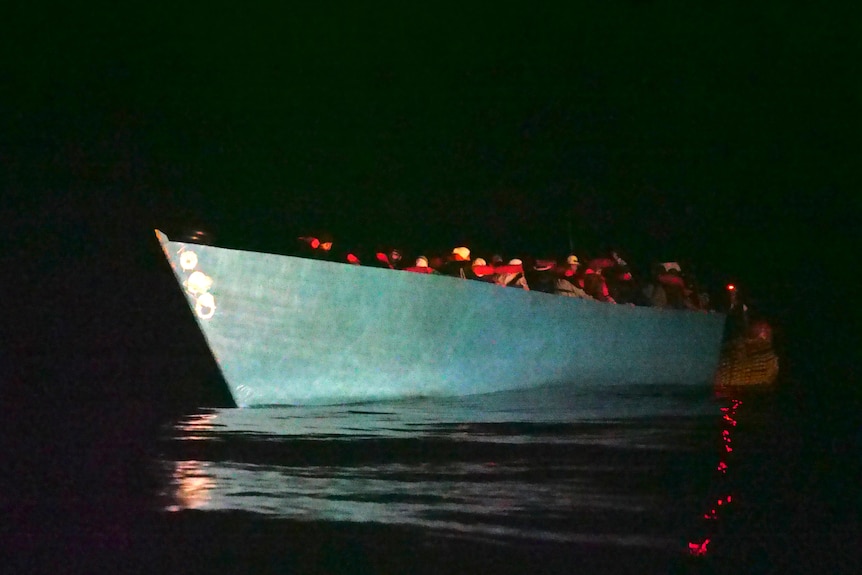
[156, 230, 725, 407]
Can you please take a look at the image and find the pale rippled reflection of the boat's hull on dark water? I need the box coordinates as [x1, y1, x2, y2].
[160, 387, 720, 548]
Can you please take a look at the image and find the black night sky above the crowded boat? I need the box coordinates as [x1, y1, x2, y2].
[0, 1, 860, 306]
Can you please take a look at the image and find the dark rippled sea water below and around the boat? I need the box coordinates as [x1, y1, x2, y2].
[0, 378, 862, 574]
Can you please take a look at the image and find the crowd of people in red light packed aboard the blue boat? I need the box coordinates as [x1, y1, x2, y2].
[299, 235, 732, 311]
